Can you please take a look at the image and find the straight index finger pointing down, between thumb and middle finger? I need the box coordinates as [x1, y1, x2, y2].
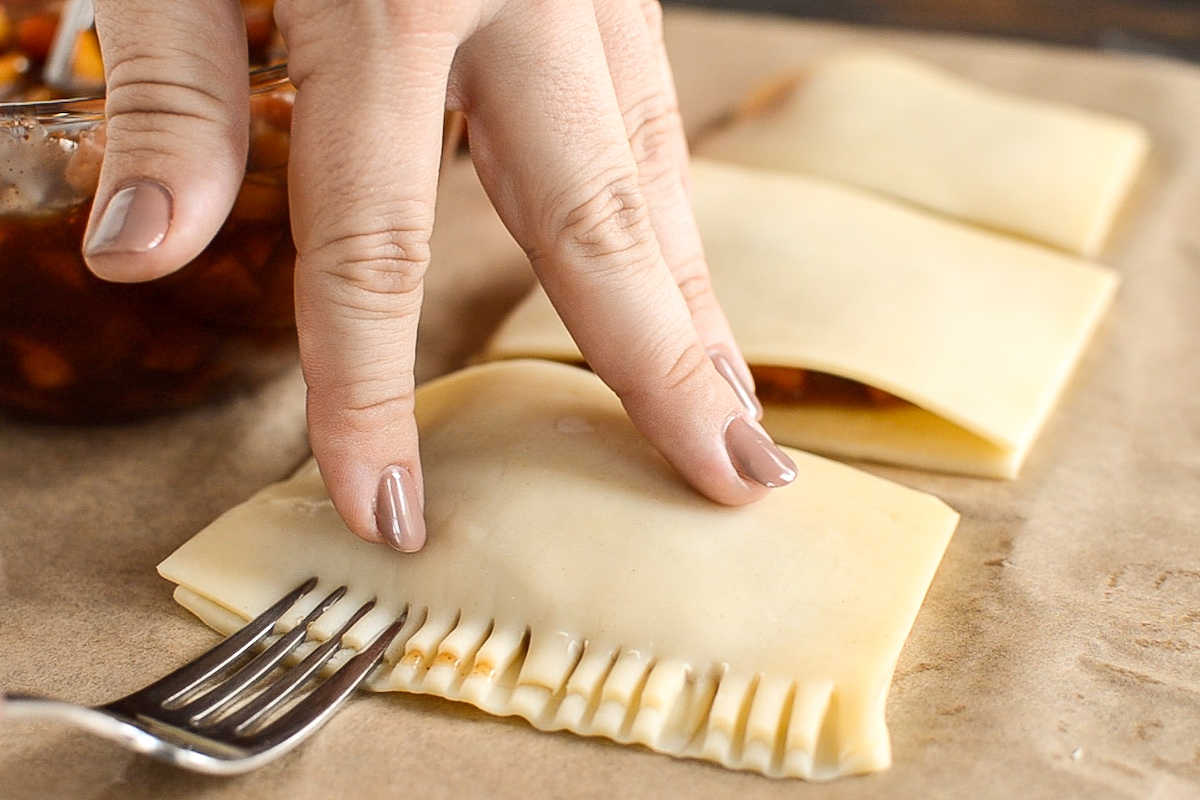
[280, 2, 460, 551]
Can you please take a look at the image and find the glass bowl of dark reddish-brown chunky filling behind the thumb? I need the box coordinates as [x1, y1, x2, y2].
[0, 0, 296, 422]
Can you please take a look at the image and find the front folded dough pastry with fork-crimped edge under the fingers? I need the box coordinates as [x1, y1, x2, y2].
[160, 361, 958, 778]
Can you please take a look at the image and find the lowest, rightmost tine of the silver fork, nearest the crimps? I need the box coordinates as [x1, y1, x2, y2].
[242, 610, 408, 752]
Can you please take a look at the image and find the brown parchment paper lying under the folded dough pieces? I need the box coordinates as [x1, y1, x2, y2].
[0, 11, 1200, 800]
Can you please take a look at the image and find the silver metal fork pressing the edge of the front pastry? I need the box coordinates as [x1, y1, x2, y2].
[0, 578, 407, 775]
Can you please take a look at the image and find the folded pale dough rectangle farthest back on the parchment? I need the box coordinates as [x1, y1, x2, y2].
[696, 49, 1148, 255]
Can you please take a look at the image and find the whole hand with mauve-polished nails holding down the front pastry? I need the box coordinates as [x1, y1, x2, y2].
[84, 0, 794, 551]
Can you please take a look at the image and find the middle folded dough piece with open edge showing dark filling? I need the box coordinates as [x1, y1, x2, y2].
[484, 160, 1117, 477]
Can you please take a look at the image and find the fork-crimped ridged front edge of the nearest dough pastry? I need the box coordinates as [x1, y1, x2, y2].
[175, 578, 890, 780]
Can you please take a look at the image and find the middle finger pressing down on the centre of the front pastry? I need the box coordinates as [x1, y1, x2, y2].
[456, 0, 786, 504]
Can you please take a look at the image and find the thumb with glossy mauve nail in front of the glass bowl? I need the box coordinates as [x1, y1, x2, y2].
[84, 0, 248, 281]
